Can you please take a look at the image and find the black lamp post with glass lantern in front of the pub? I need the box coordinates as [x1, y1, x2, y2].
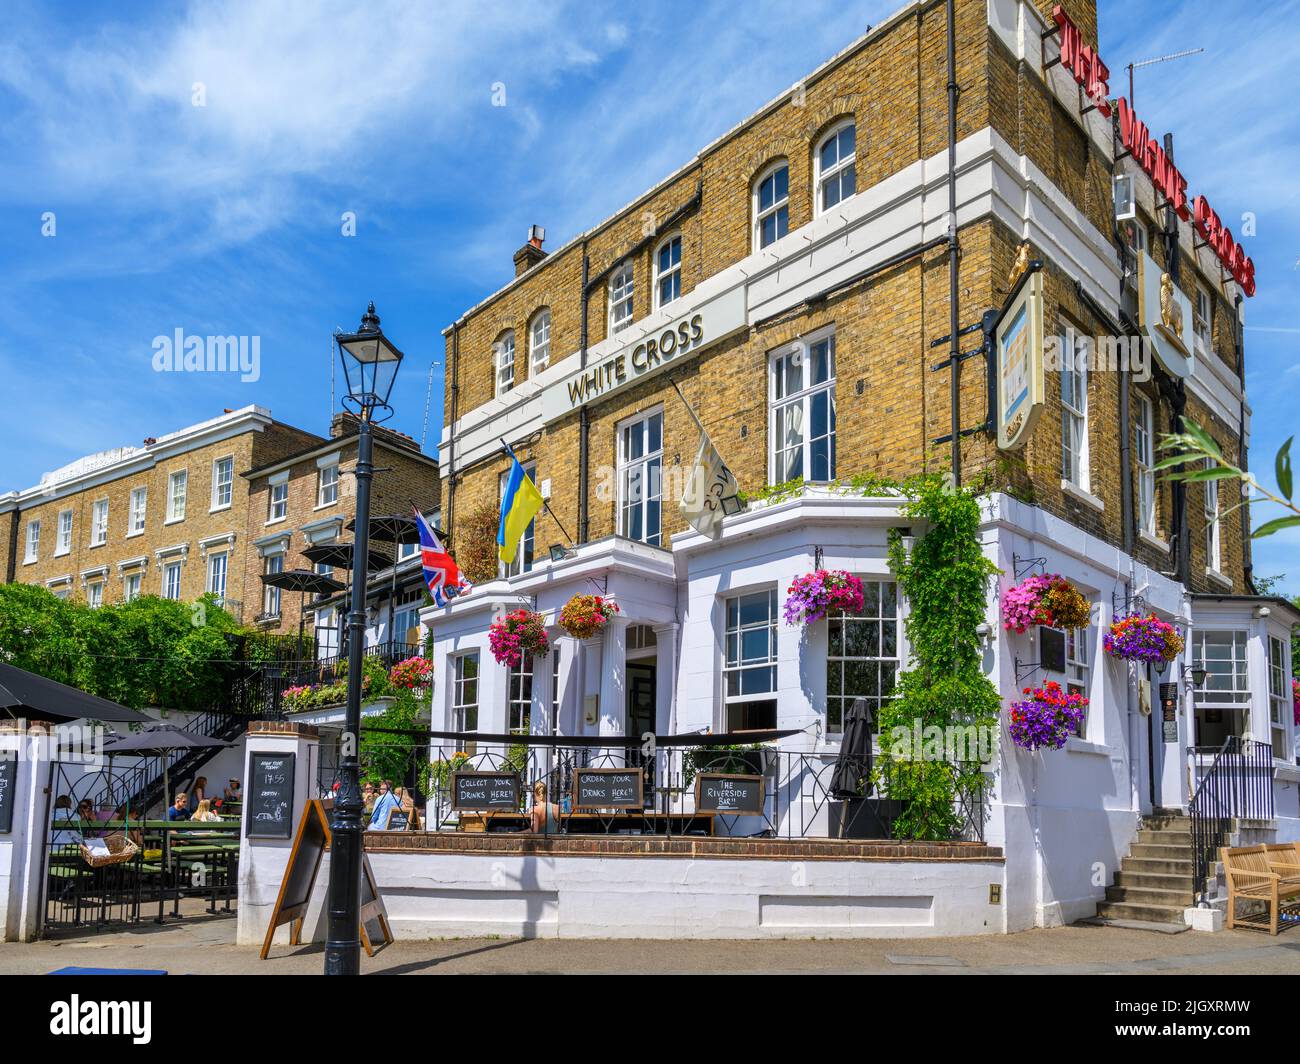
[325, 296, 402, 976]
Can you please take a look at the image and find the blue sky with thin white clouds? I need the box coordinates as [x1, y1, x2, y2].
[0, 0, 1300, 593]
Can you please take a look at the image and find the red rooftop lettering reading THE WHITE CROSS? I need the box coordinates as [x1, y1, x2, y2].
[1052, 4, 1255, 295]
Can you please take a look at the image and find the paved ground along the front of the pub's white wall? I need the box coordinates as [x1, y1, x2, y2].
[0, 916, 1300, 976]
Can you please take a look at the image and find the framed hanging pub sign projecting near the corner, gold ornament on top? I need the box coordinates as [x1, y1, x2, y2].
[993, 262, 1044, 450]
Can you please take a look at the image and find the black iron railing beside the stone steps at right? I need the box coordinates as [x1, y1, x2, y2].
[1188, 735, 1273, 904]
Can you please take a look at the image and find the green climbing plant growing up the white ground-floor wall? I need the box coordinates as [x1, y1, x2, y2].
[875, 475, 1000, 839]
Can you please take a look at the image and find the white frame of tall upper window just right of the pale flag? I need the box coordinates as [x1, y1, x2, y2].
[767, 325, 837, 484]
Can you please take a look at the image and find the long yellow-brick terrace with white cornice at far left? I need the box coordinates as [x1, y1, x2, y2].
[0, 406, 320, 620]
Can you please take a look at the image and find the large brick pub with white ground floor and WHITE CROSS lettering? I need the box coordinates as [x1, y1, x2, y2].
[425, 0, 1300, 934]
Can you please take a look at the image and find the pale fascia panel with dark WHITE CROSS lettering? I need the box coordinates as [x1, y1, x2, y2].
[542, 287, 745, 421]
